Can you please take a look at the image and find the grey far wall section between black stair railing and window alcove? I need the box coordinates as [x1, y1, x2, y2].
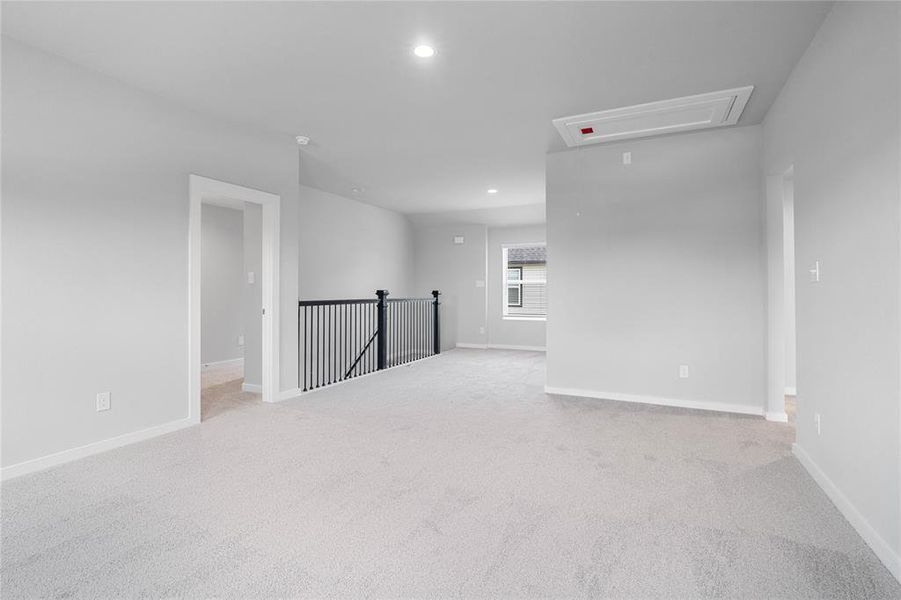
[414, 224, 488, 350]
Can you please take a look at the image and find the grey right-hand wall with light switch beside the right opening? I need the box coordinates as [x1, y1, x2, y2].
[764, 2, 901, 577]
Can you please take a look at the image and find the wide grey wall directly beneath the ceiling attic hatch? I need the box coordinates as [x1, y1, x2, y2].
[547, 127, 766, 413]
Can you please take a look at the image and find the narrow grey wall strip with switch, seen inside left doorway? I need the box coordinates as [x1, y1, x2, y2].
[240, 202, 262, 386]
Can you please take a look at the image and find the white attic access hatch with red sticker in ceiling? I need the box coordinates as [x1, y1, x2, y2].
[553, 85, 754, 146]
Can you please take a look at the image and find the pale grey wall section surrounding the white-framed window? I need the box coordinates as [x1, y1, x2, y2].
[487, 225, 550, 348]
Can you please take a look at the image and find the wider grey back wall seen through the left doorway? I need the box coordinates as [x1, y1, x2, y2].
[200, 204, 244, 364]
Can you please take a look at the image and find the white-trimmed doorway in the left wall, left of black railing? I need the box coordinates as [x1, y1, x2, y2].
[188, 175, 280, 422]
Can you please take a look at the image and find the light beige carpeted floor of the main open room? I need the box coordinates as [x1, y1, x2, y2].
[0, 350, 901, 600]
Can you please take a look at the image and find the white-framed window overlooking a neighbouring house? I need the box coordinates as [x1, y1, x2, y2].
[503, 243, 547, 319]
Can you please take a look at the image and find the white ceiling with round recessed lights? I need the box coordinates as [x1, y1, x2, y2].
[2, 2, 829, 214]
